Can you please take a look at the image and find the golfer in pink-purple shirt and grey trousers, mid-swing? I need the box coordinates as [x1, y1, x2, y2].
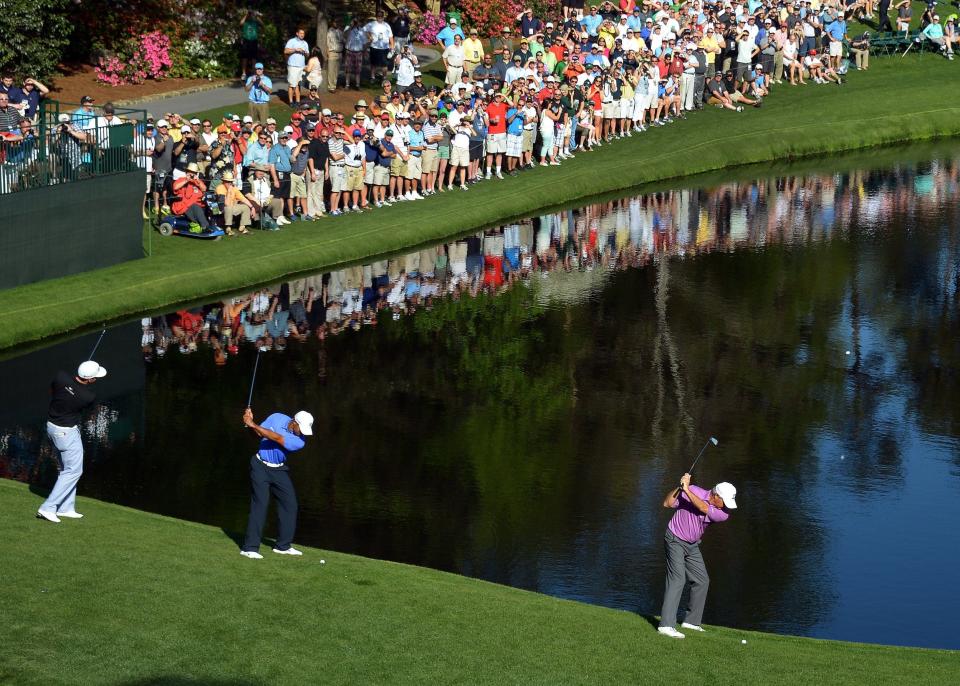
[657, 474, 737, 638]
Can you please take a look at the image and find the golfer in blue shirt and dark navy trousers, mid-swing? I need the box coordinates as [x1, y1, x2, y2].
[240, 407, 313, 560]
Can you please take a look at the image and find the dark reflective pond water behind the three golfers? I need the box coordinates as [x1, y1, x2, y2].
[0, 156, 960, 648]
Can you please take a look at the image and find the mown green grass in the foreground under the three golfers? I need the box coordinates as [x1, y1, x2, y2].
[0, 482, 960, 686]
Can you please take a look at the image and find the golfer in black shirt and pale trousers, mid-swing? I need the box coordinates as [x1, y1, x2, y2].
[37, 360, 107, 524]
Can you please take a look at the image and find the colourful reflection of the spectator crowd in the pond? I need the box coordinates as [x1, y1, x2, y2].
[142, 160, 958, 364]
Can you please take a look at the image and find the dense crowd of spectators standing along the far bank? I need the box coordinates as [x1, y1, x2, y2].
[137, 0, 953, 234]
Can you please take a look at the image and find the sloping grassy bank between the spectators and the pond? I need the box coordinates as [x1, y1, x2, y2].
[0, 55, 960, 348]
